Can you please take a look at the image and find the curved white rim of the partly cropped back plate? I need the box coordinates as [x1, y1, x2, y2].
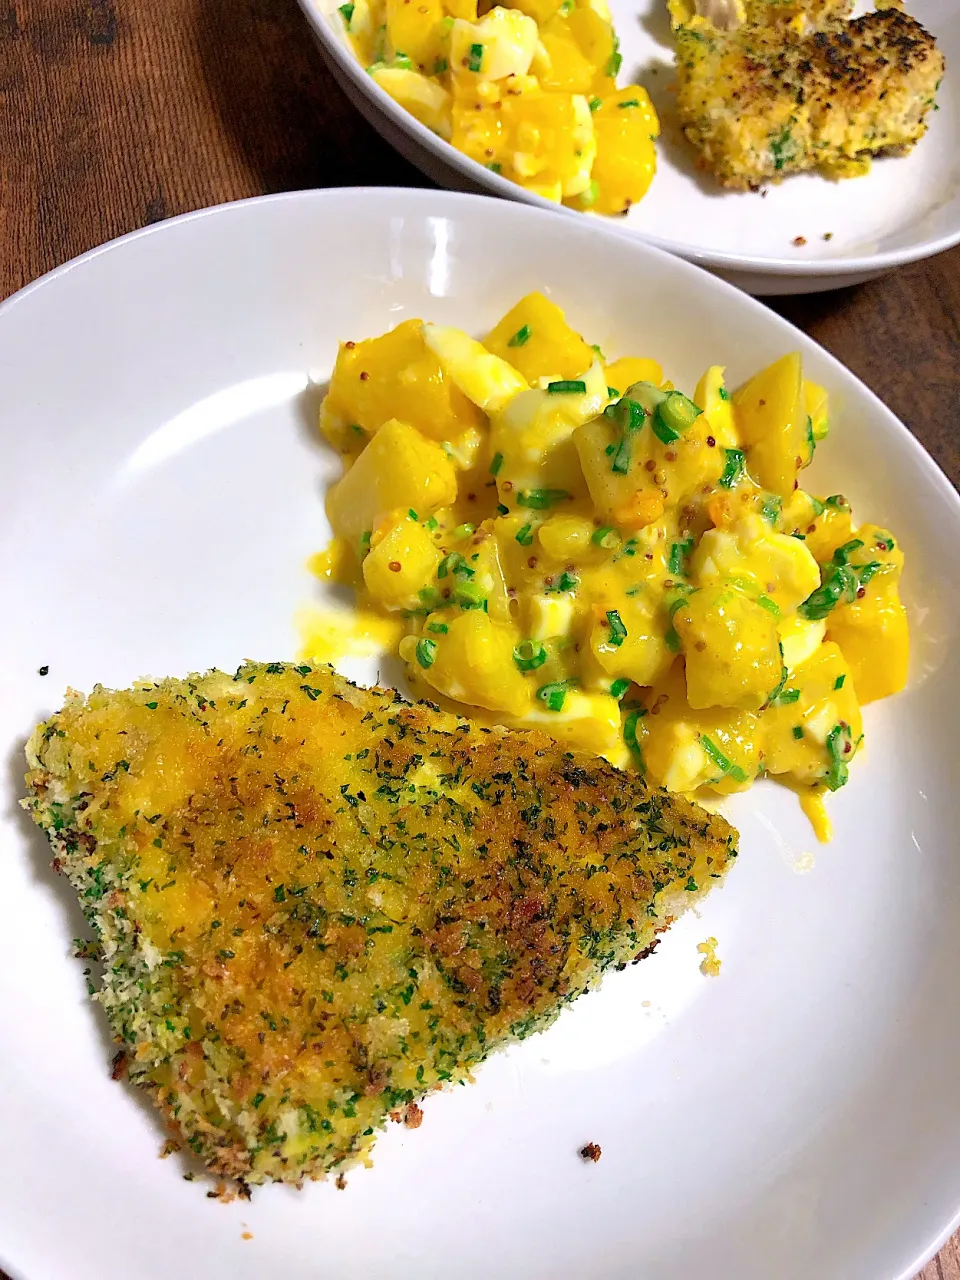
[297, 0, 960, 279]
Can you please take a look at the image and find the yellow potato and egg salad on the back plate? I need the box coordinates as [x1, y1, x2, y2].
[339, 0, 660, 214]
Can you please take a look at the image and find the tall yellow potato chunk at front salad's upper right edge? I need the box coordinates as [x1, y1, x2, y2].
[733, 352, 810, 498]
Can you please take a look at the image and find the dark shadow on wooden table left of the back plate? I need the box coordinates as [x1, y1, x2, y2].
[193, 0, 430, 192]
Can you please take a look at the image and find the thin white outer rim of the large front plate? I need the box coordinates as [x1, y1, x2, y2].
[0, 187, 960, 1280]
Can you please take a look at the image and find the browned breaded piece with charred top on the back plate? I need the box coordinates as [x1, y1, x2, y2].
[676, 9, 943, 189]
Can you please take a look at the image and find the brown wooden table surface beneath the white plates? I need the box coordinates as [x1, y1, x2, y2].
[0, 0, 960, 1280]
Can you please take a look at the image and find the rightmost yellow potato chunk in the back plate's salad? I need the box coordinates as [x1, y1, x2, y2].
[585, 84, 660, 214]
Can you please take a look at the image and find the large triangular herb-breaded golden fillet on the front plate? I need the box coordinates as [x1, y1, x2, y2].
[24, 663, 736, 1183]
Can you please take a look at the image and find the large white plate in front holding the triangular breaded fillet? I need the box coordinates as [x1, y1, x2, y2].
[0, 189, 960, 1280]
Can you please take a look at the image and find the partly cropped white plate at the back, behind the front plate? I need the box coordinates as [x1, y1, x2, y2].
[300, 0, 960, 294]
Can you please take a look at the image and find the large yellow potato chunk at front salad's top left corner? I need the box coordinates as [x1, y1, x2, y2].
[320, 320, 483, 449]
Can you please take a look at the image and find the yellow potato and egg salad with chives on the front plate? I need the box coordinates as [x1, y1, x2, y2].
[320, 293, 908, 836]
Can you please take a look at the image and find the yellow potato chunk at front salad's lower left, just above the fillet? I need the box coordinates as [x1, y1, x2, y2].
[401, 609, 534, 714]
